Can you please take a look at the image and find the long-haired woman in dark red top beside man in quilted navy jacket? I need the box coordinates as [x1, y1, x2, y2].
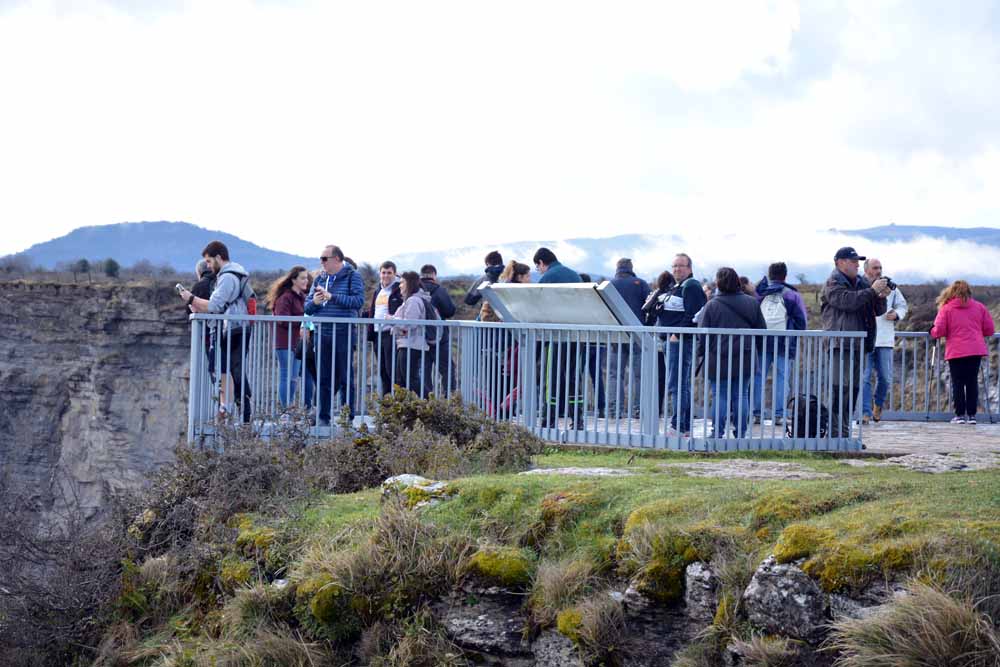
[267, 266, 313, 408]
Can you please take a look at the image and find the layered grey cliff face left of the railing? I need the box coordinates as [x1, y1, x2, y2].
[0, 282, 190, 519]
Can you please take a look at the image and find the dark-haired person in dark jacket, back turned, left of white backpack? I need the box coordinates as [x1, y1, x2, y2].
[701, 267, 767, 438]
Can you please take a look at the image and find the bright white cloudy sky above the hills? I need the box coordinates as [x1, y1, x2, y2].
[0, 0, 1000, 275]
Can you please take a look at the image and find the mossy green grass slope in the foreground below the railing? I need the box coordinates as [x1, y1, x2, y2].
[99, 449, 1000, 666]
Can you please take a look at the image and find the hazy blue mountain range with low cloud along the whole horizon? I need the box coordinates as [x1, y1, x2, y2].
[9, 221, 1000, 283]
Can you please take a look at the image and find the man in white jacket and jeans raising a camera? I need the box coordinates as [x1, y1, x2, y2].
[861, 257, 907, 424]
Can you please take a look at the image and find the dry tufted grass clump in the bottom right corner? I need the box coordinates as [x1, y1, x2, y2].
[829, 584, 1000, 667]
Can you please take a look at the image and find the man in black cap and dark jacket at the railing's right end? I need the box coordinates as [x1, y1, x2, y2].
[820, 247, 891, 438]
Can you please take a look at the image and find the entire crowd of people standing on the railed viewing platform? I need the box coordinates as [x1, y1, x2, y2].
[178, 241, 994, 438]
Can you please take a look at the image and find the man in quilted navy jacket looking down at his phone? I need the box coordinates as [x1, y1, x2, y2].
[305, 245, 365, 426]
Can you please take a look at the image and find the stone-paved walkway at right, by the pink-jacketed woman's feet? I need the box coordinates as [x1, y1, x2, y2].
[863, 418, 1000, 454]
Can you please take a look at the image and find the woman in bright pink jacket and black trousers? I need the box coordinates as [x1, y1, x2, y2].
[931, 280, 996, 424]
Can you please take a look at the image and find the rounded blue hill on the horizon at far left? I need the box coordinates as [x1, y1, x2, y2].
[10, 221, 308, 271]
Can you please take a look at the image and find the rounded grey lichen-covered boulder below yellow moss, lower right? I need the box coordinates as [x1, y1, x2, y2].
[743, 556, 828, 641]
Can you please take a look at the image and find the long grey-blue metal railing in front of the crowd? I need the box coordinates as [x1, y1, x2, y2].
[188, 314, 940, 451]
